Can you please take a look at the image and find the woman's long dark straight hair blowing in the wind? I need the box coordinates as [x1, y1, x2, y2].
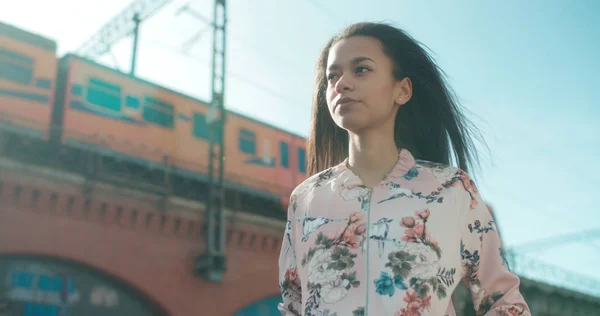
[307, 23, 486, 176]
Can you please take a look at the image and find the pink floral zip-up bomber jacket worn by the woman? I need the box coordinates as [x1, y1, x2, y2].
[278, 150, 531, 316]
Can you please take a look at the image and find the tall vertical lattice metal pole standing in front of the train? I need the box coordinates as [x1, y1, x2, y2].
[185, 0, 227, 282]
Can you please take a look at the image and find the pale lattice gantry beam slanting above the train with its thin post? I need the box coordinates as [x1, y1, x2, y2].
[77, 0, 171, 75]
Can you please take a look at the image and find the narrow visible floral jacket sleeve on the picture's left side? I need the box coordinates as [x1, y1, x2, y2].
[277, 199, 302, 316]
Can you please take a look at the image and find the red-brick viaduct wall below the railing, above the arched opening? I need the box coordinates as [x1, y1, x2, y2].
[0, 170, 284, 316]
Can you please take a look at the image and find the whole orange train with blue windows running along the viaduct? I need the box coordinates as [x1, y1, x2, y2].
[0, 22, 307, 208]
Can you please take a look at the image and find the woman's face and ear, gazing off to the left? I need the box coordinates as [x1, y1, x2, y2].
[325, 36, 411, 133]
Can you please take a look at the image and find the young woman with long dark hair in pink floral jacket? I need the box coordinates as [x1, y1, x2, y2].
[279, 23, 530, 316]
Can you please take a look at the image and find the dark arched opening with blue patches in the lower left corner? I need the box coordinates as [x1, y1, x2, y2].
[0, 256, 164, 316]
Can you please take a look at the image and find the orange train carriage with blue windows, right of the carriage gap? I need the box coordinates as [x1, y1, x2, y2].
[55, 55, 305, 204]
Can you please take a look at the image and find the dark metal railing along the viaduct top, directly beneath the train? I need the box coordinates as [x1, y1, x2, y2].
[0, 113, 293, 219]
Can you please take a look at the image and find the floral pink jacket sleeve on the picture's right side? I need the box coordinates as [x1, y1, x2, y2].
[454, 170, 531, 316]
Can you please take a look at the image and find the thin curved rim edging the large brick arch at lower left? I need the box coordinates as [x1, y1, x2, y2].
[0, 252, 168, 316]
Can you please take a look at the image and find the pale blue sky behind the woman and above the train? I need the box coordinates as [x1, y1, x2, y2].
[0, 0, 600, 296]
